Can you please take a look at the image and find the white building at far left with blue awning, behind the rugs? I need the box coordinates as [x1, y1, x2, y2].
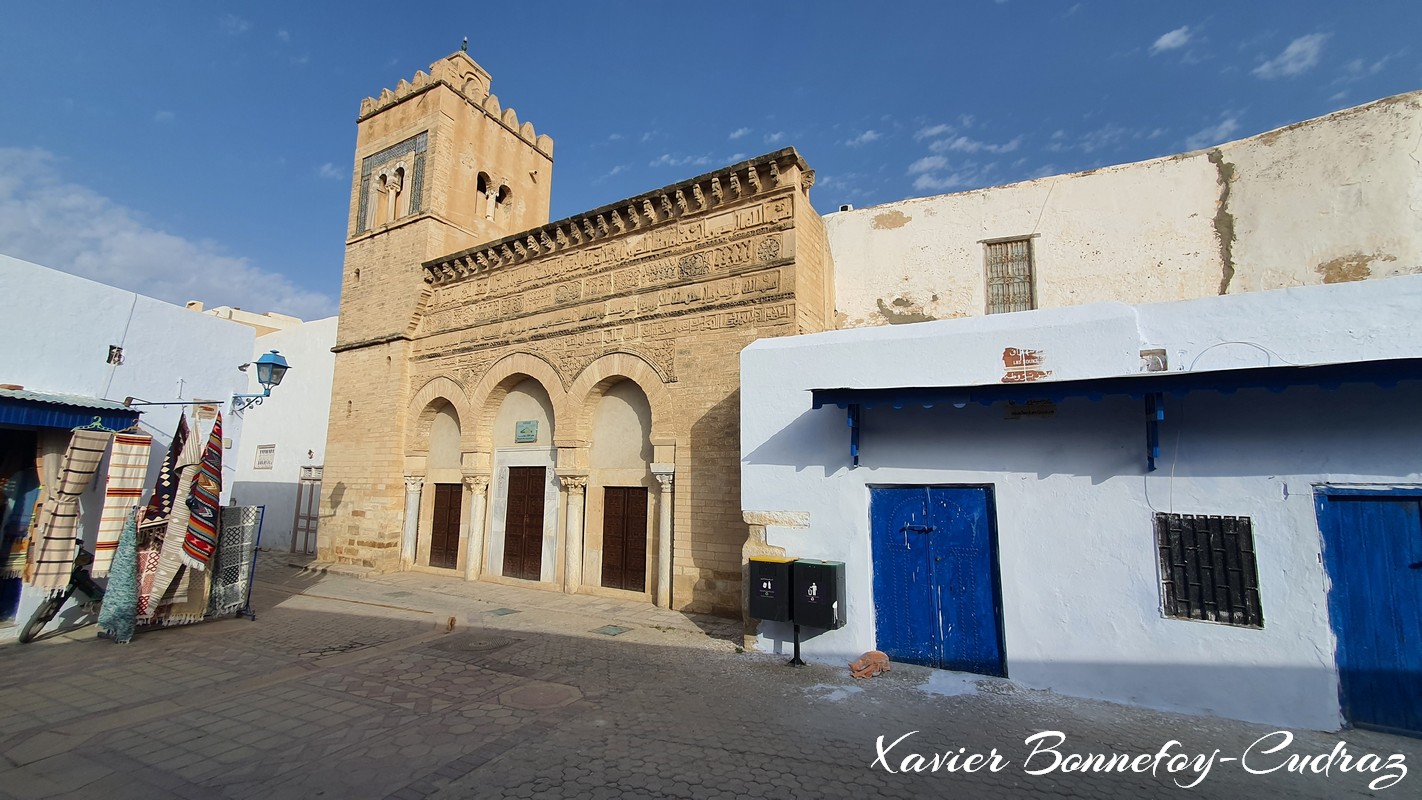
[0, 256, 255, 637]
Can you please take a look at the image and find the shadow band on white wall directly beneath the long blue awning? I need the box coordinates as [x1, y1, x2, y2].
[744, 382, 1422, 483]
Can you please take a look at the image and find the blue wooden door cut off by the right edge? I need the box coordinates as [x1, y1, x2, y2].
[1318, 489, 1422, 733]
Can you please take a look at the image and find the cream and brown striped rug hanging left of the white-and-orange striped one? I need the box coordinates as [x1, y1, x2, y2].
[26, 431, 112, 590]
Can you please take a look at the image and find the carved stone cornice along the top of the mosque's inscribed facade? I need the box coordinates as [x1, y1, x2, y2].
[424, 148, 815, 286]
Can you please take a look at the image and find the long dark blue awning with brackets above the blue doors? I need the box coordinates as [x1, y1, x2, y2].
[811, 358, 1422, 472]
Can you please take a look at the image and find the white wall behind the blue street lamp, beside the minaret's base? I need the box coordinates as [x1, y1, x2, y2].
[232, 317, 337, 551]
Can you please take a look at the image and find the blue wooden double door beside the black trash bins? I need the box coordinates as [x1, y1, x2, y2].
[869, 486, 1005, 675]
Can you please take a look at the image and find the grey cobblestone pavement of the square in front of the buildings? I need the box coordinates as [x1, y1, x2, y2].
[0, 554, 1422, 800]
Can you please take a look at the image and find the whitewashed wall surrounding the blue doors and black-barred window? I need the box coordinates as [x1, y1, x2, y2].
[741, 277, 1422, 729]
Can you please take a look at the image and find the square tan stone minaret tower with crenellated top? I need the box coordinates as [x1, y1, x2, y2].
[320, 50, 553, 568]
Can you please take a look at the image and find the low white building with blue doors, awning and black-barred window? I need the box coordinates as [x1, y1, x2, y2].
[741, 276, 1422, 730]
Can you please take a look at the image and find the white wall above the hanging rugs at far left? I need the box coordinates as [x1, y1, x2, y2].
[0, 256, 255, 621]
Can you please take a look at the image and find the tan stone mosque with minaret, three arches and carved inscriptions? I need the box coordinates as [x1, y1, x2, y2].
[319, 53, 833, 617]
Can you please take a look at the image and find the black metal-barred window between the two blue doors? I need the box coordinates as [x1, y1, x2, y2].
[1155, 514, 1264, 628]
